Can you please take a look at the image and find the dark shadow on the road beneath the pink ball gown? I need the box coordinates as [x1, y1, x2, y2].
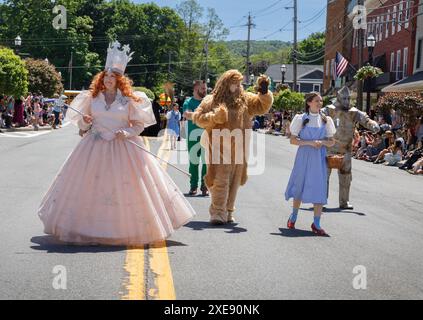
[31, 235, 186, 254]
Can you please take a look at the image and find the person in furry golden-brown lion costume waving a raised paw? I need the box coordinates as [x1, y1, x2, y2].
[185, 70, 273, 225]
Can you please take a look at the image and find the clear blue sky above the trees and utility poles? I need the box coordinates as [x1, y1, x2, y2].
[134, 0, 327, 41]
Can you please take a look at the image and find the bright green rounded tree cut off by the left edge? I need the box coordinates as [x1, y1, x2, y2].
[0, 47, 28, 97]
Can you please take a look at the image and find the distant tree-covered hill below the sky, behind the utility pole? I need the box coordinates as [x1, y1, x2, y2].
[224, 40, 291, 56]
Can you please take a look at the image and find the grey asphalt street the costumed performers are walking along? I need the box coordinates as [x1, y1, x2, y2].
[0, 126, 423, 300]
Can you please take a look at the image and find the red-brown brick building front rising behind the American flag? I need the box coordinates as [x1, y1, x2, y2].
[323, 0, 423, 92]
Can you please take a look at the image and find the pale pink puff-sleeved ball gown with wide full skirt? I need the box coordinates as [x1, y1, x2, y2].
[38, 91, 195, 246]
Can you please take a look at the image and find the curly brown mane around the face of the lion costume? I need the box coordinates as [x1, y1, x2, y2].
[212, 70, 247, 108]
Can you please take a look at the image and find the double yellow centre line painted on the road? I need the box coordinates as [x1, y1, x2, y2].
[122, 135, 176, 300]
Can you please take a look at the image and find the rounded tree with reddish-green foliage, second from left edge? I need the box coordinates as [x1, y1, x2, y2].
[25, 59, 63, 97]
